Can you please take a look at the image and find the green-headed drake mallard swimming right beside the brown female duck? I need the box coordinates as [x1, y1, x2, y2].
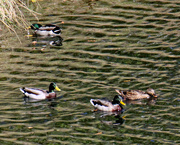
[90, 95, 126, 112]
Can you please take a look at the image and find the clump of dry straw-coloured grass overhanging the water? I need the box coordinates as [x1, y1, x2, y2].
[0, 0, 37, 33]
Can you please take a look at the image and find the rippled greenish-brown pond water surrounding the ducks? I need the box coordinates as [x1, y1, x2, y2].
[0, 0, 180, 145]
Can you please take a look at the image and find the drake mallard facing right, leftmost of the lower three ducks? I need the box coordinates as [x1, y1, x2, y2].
[20, 83, 61, 100]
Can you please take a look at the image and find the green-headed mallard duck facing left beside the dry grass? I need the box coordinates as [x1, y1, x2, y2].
[29, 24, 61, 36]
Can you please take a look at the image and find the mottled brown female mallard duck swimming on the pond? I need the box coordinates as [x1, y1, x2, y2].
[116, 89, 157, 100]
